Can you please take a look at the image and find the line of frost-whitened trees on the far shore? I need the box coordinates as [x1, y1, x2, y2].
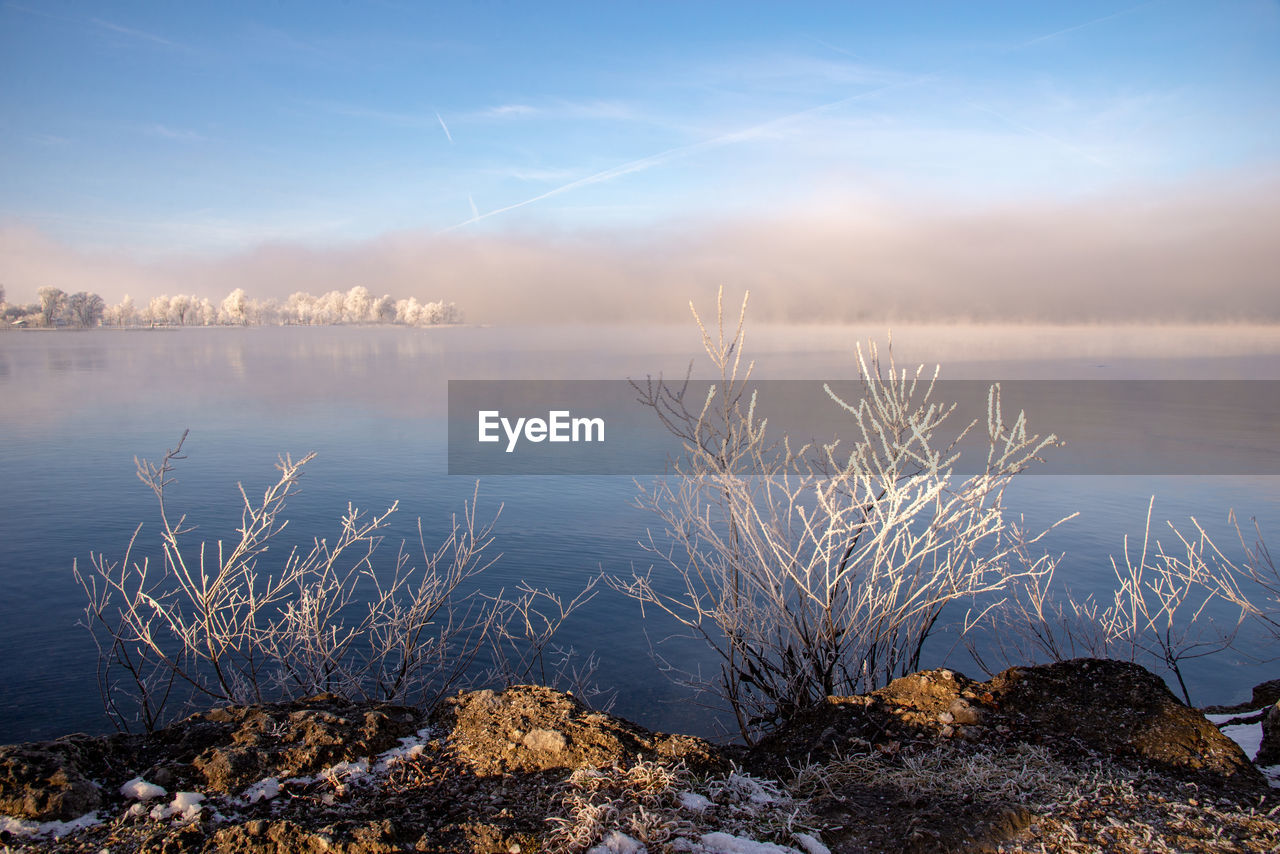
[0, 286, 462, 329]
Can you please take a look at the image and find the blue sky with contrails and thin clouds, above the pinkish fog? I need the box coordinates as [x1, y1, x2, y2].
[0, 0, 1280, 320]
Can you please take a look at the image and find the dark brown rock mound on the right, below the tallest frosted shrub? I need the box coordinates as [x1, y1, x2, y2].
[755, 658, 1264, 787]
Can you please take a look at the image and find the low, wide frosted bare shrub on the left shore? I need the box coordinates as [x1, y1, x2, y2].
[76, 433, 502, 730]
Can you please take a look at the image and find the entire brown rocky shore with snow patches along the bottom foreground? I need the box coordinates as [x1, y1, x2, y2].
[0, 659, 1280, 854]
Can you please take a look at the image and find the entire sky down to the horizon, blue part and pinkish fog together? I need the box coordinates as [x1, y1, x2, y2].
[0, 0, 1280, 323]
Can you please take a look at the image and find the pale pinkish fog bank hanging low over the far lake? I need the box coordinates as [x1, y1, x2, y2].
[0, 177, 1280, 324]
